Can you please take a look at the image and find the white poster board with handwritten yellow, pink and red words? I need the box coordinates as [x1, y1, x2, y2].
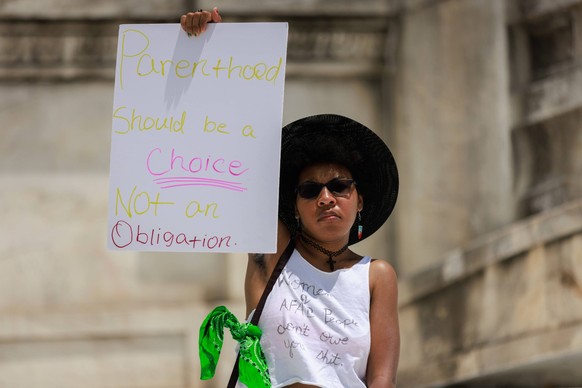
[108, 23, 288, 252]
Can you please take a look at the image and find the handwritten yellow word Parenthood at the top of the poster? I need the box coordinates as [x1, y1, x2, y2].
[118, 29, 283, 89]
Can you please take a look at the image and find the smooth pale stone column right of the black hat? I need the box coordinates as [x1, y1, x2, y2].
[394, 0, 514, 275]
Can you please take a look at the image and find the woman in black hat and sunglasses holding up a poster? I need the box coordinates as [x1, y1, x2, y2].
[186, 8, 400, 388]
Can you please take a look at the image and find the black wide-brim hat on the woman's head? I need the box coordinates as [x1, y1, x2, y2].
[279, 114, 398, 245]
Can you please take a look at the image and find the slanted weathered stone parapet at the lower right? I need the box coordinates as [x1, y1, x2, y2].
[399, 200, 582, 387]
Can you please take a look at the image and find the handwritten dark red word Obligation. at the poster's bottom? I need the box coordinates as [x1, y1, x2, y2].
[111, 220, 236, 251]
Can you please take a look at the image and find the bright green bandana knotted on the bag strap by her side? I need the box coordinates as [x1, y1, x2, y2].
[198, 306, 271, 388]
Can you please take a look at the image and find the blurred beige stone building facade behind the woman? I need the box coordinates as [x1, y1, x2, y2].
[0, 0, 582, 388]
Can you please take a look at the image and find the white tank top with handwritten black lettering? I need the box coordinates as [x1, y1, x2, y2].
[253, 250, 371, 388]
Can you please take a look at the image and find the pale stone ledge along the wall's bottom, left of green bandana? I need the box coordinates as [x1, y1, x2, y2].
[0, 303, 230, 388]
